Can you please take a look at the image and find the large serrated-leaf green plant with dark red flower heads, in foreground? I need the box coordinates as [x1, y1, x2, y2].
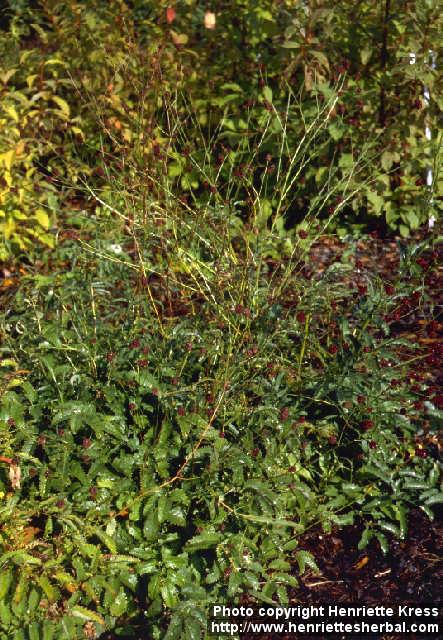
[0, 107, 442, 639]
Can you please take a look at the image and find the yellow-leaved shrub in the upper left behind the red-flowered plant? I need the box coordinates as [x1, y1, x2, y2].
[0, 2, 173, 260]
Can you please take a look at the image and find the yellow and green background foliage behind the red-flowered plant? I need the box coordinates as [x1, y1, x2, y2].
[0, 0, 441, 259]
